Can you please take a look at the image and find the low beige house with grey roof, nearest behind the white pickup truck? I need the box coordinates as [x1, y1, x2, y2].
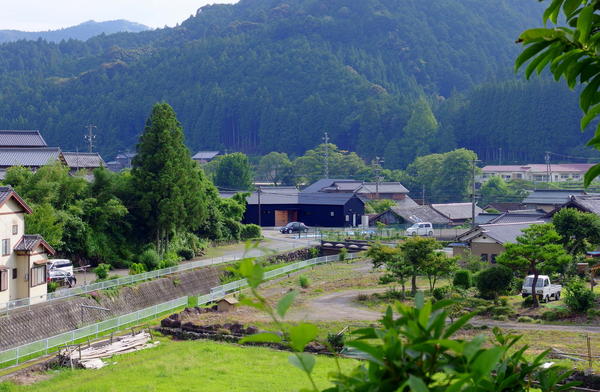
[450, 220, 545, 263]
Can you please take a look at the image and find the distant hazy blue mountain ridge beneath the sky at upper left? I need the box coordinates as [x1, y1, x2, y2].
[0, 19, 149, 43]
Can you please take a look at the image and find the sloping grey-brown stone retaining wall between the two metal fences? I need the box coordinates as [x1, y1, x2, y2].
[0, 267, 222, 351]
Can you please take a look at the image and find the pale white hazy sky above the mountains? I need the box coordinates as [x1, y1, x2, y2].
[0, 0, 236, 31]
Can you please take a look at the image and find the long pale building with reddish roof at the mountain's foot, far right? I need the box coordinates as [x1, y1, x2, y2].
[476, 163, 594, 183]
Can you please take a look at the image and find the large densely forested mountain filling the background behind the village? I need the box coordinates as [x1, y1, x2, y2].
[0, 0, 585, 167]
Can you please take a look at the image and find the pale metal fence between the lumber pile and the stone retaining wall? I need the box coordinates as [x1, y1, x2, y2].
[0, 297, 188, 367]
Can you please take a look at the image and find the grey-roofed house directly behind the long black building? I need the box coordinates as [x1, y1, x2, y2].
[302, 179, 416, 204]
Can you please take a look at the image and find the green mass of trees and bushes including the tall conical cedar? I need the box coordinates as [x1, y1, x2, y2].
[4, 103, 260, 268]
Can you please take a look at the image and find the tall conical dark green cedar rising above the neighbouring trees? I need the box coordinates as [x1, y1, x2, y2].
[132, 103, 206, 253]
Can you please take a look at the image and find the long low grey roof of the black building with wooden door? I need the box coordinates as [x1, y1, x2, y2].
[247, 192, 360, 205]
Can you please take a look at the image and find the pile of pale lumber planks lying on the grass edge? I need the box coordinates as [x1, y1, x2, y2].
[58, 331, 158, 369]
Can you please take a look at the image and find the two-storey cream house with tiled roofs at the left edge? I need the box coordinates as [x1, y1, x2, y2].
[0, 186, 54, 306]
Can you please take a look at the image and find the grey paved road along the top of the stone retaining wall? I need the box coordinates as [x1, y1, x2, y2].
[68, 230, 318, 285]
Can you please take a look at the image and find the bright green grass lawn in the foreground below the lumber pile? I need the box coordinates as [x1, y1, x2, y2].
[0, 339, 356, 392]
